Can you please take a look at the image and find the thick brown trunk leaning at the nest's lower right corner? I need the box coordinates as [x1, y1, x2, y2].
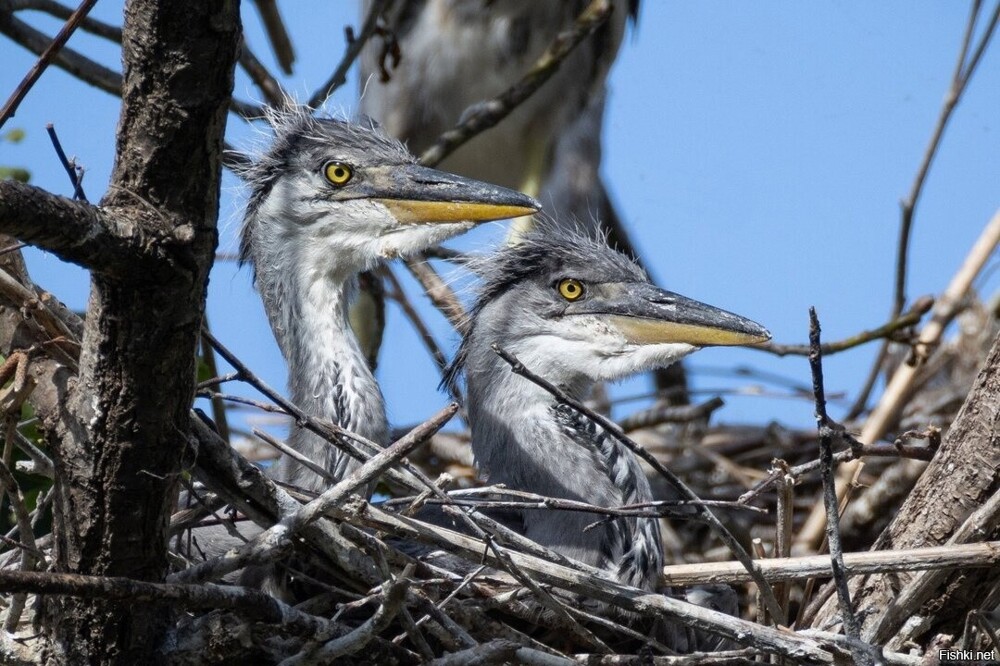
[812, 326, 1000, 645]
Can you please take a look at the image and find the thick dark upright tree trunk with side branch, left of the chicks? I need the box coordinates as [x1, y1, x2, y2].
[0, 0, 240, 664]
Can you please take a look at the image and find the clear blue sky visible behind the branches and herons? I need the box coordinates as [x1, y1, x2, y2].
[0, 0, 1000, 438]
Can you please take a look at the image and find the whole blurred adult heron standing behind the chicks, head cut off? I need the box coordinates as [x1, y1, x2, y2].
[358, 0, 652, 376]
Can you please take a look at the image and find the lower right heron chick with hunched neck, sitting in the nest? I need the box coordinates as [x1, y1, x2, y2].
[446, 228, 770, 590]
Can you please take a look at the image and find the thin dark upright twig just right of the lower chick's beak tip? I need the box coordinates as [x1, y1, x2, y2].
[809, 308, 874, 665]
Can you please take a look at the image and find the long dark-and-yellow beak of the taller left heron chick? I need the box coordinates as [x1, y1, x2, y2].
[369, 164, 541, 224]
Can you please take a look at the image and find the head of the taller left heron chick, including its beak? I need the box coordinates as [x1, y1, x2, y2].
[241, 107, 539, 273]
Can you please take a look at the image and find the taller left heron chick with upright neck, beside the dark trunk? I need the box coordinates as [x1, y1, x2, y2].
[240, 108, 538, 491]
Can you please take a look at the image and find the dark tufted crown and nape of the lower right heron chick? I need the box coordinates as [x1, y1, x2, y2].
[441, 221, 649, 388]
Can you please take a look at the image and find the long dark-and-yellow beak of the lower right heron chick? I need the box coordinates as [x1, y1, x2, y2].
[579, 283, 771, 347]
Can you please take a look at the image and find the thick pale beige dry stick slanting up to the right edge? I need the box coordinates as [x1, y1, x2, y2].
[796, 209, 1000, 551]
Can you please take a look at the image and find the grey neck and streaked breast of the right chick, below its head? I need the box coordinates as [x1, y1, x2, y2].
[466, 347, 663, 589]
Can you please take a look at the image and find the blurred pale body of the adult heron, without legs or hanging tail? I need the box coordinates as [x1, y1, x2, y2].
[360, 0, 638, 195]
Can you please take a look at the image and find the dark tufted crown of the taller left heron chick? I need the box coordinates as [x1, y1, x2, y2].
[237, 104, 416, 264]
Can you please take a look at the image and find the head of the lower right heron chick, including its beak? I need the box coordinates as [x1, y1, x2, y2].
[450, 228, 771, 385]
